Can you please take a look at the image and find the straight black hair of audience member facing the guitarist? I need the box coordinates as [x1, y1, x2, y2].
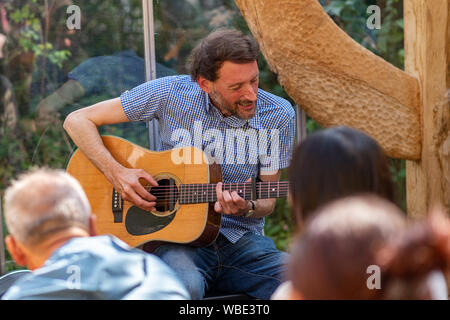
[289, 126, 394, 221]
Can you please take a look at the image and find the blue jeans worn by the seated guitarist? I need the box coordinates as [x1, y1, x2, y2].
[154, 233, 288, 299]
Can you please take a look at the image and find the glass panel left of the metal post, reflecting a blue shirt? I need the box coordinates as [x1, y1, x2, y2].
[0, 0, 148, 272]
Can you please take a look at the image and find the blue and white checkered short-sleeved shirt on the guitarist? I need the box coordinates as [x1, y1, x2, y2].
[120, 75, 295, 243]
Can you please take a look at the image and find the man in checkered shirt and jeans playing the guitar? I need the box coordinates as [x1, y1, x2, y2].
[64, 29, 295, 299]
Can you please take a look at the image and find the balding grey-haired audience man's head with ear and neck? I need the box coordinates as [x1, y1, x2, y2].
[4, 169, 96, 269]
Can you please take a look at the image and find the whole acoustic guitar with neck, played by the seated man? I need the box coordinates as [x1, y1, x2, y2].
[67, 136, 289, 246]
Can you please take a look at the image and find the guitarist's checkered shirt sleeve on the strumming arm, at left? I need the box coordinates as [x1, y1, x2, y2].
[120, 77, 174, 121]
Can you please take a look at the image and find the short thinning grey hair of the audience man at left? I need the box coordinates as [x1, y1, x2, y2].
[5, 169, 91, 244]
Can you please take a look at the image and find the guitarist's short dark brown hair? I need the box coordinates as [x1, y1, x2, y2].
[188, 29, 259, 81]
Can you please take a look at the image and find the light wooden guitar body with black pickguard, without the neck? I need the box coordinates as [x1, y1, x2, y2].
[67, 136, 222, 247]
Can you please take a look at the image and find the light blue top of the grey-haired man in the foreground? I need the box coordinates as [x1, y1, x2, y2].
[2, 235, 189, 300]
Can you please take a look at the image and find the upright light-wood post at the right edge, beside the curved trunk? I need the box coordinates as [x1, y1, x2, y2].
[404, 0, 450, 217]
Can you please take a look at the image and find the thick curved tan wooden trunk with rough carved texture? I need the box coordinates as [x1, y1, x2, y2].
[236, 0, 422, 160]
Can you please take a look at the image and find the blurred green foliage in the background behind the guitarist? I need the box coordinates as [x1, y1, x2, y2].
[0, 0, 405, 269]
